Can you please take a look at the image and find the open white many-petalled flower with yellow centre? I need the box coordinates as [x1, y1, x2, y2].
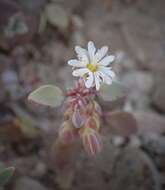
[68, 41, 115, 90]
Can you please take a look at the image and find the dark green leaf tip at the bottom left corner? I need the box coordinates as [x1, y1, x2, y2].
[0, 167, 14, 186]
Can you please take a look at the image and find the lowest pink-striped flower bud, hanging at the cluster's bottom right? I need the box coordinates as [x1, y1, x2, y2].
[80, 128, 102, 156]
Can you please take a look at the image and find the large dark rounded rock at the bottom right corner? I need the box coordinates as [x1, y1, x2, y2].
[111, 148, 161, 190]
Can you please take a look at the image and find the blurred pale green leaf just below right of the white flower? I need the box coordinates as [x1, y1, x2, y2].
[99, 81, 126, 101]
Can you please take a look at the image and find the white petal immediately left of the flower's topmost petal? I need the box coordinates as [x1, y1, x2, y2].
[75, 46, 89, 65]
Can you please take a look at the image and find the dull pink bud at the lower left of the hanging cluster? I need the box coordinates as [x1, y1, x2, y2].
[59, 121, 78, 143]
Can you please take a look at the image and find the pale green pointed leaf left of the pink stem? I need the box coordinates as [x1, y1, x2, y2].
[28, 85, 64, 107]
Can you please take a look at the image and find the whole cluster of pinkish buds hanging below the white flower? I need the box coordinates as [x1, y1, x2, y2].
[59, 79, 102, 155]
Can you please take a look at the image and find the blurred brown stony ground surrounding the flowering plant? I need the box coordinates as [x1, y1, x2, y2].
[0, 0, 165, 190]
